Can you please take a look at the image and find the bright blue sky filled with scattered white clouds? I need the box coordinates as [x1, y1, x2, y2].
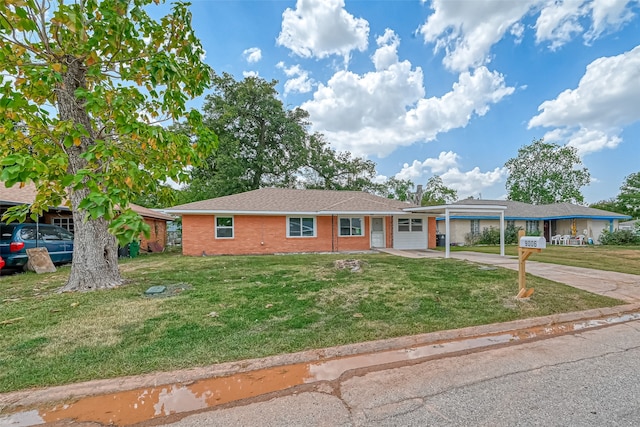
[164, 0, 640, 203]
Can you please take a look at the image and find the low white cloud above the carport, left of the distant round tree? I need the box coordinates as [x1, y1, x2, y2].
[395, 151, 507, 198]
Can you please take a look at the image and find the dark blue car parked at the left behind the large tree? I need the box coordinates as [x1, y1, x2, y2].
[0, 223, 73, 269]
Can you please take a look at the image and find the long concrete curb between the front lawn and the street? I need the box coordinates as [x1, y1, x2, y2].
[0, 304, 640, 414]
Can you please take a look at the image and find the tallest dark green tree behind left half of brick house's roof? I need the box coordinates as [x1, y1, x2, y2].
[187, 73, 308, 198]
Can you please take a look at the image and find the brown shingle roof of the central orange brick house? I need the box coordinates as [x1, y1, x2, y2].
[165, 188, 416, 214]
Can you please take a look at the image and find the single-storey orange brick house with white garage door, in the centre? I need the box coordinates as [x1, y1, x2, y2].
[165, 188, 436, 256]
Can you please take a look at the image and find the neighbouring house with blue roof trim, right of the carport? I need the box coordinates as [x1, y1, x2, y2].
[437, 199, 630, 244]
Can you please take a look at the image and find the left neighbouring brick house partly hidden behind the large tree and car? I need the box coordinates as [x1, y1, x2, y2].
[0, 182, 174, 250]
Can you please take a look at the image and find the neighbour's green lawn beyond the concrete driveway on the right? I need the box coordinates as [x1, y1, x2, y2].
[448, 245, 640, 274]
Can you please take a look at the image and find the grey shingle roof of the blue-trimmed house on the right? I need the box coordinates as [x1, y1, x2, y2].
[444, 199, 630, 219]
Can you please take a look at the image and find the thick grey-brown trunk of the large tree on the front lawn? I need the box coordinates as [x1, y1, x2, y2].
[56, 56, 123, 291]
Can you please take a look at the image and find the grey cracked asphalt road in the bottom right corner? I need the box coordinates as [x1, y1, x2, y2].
[165, 321, 640, 427]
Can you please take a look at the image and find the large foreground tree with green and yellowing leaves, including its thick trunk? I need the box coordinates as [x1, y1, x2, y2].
[0, 0, 215, 290]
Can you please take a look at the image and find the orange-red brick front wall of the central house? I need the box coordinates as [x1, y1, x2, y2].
[182, 215, 371, 256]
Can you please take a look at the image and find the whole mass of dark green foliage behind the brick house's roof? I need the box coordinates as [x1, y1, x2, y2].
[179, 73, 388, 203]
